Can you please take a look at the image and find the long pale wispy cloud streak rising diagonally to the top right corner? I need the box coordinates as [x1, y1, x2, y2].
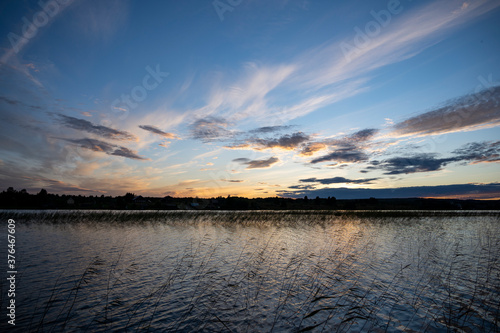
[197, 0, 500, 125]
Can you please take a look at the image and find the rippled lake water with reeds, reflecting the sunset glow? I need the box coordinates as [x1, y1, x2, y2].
[0, 211, 500, 332]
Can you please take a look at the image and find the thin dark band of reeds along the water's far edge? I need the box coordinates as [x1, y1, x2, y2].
[0, 210, 500, 224]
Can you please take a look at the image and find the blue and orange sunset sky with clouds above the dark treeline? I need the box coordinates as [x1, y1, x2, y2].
[0, 0, 500, 199]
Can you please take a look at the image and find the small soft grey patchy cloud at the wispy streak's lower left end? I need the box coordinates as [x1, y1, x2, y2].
[190, 117, 235, 142]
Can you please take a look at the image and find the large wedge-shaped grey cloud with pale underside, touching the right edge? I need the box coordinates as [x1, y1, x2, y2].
[392, 86, 500, 136]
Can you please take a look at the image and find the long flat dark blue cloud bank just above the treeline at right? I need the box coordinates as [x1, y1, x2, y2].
[277, 183, 500, 199]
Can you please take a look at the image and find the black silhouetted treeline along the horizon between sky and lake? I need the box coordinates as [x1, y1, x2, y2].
[0, 187, 500, 210]
